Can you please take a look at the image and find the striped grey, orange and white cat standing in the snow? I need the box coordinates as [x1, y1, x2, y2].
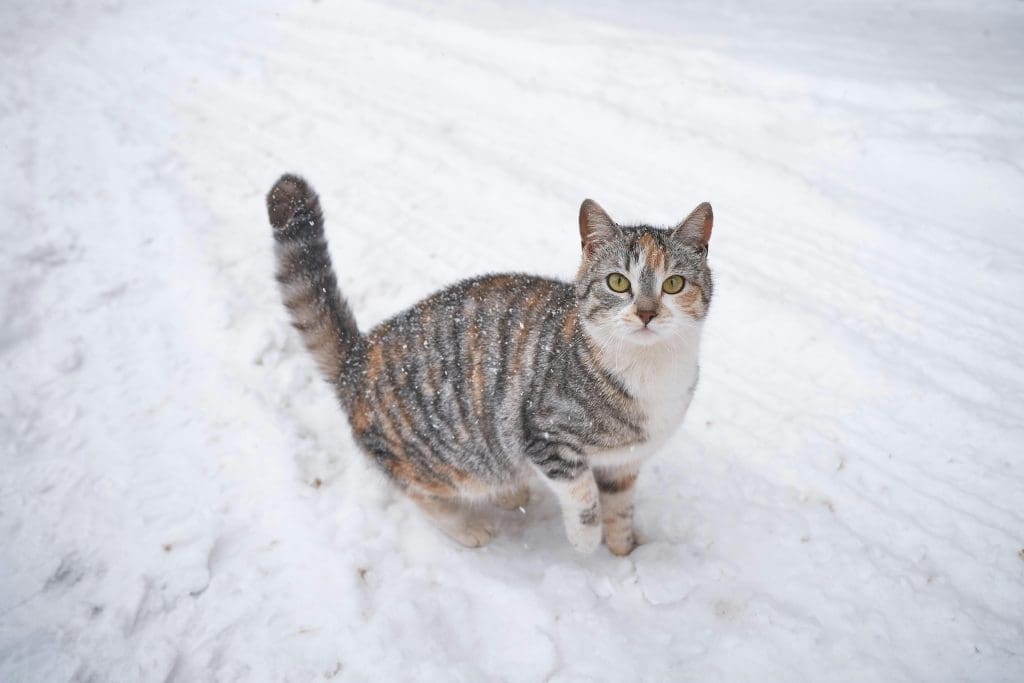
[266, 174, 713, 555]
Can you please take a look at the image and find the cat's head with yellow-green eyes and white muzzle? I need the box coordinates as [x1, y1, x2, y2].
[575, 200, 713, 346]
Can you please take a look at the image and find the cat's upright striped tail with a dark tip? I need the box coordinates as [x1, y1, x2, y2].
[266, 174, 362, 398]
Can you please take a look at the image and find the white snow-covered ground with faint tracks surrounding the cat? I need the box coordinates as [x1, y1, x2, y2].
[0, 0, 1024, 682]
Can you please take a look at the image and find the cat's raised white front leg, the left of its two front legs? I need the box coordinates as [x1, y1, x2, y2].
[531, 446, 601, 553]
